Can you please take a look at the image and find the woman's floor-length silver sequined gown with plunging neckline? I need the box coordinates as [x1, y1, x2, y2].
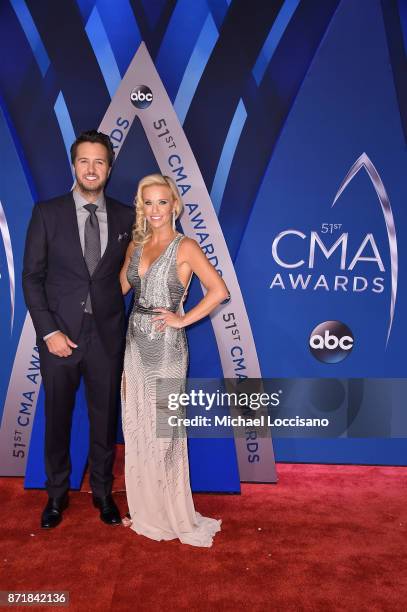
[122, 234, 221, 546]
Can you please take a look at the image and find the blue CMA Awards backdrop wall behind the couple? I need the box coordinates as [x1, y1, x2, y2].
[0, 0, 407, 491]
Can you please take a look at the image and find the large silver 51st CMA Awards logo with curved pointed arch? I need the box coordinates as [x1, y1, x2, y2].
[270, 153, 398, 346]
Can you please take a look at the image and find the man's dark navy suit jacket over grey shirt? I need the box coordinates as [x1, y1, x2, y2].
[23, 193, 134, 355]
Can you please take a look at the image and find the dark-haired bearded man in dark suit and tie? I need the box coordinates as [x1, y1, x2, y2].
[23, 130, 134, 528]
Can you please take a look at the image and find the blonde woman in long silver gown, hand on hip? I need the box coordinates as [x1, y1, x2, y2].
[120, 174, 229, 546]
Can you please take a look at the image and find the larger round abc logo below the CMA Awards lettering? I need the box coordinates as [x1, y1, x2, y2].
[309, 321, 353, 363]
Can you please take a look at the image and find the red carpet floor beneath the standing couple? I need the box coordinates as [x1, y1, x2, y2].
[0, 448, 407, 612]
